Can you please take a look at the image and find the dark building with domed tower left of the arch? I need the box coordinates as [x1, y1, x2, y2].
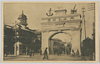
[4, 11, 41, 56]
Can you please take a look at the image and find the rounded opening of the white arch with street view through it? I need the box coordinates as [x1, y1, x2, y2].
[48, 32, 72, 55]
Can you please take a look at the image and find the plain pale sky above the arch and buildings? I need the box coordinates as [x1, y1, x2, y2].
[3, 2, 94, 41]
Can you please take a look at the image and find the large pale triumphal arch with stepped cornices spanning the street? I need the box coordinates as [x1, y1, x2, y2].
[41, 9, 82, 53]
